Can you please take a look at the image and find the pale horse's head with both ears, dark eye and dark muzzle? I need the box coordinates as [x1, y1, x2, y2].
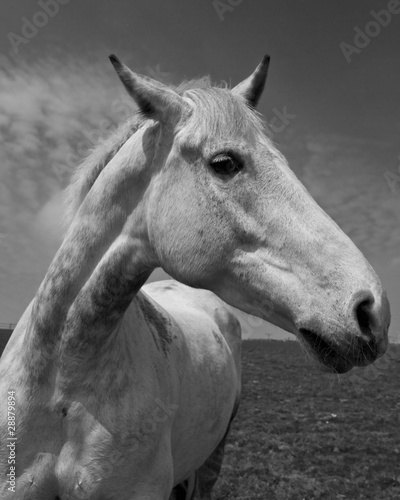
[112, 57, 390, 372]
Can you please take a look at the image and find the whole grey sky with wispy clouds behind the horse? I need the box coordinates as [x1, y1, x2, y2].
[0, 0, 400, 341]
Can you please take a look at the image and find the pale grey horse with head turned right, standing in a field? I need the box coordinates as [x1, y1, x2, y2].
[0, 52, 390, 500]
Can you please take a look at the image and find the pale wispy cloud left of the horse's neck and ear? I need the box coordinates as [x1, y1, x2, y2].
[0, 52, 135, 321]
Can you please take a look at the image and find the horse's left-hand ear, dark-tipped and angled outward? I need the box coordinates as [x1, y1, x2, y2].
[110, 54, 187, 121]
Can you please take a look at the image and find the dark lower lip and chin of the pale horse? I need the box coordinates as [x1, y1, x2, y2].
[299, 328, 357, 373]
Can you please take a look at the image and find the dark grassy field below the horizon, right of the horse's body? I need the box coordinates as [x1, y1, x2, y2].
[0, 339, 400, 500]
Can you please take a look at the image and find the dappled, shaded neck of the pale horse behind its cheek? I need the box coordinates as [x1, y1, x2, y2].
[26, 127, 154, 376]
